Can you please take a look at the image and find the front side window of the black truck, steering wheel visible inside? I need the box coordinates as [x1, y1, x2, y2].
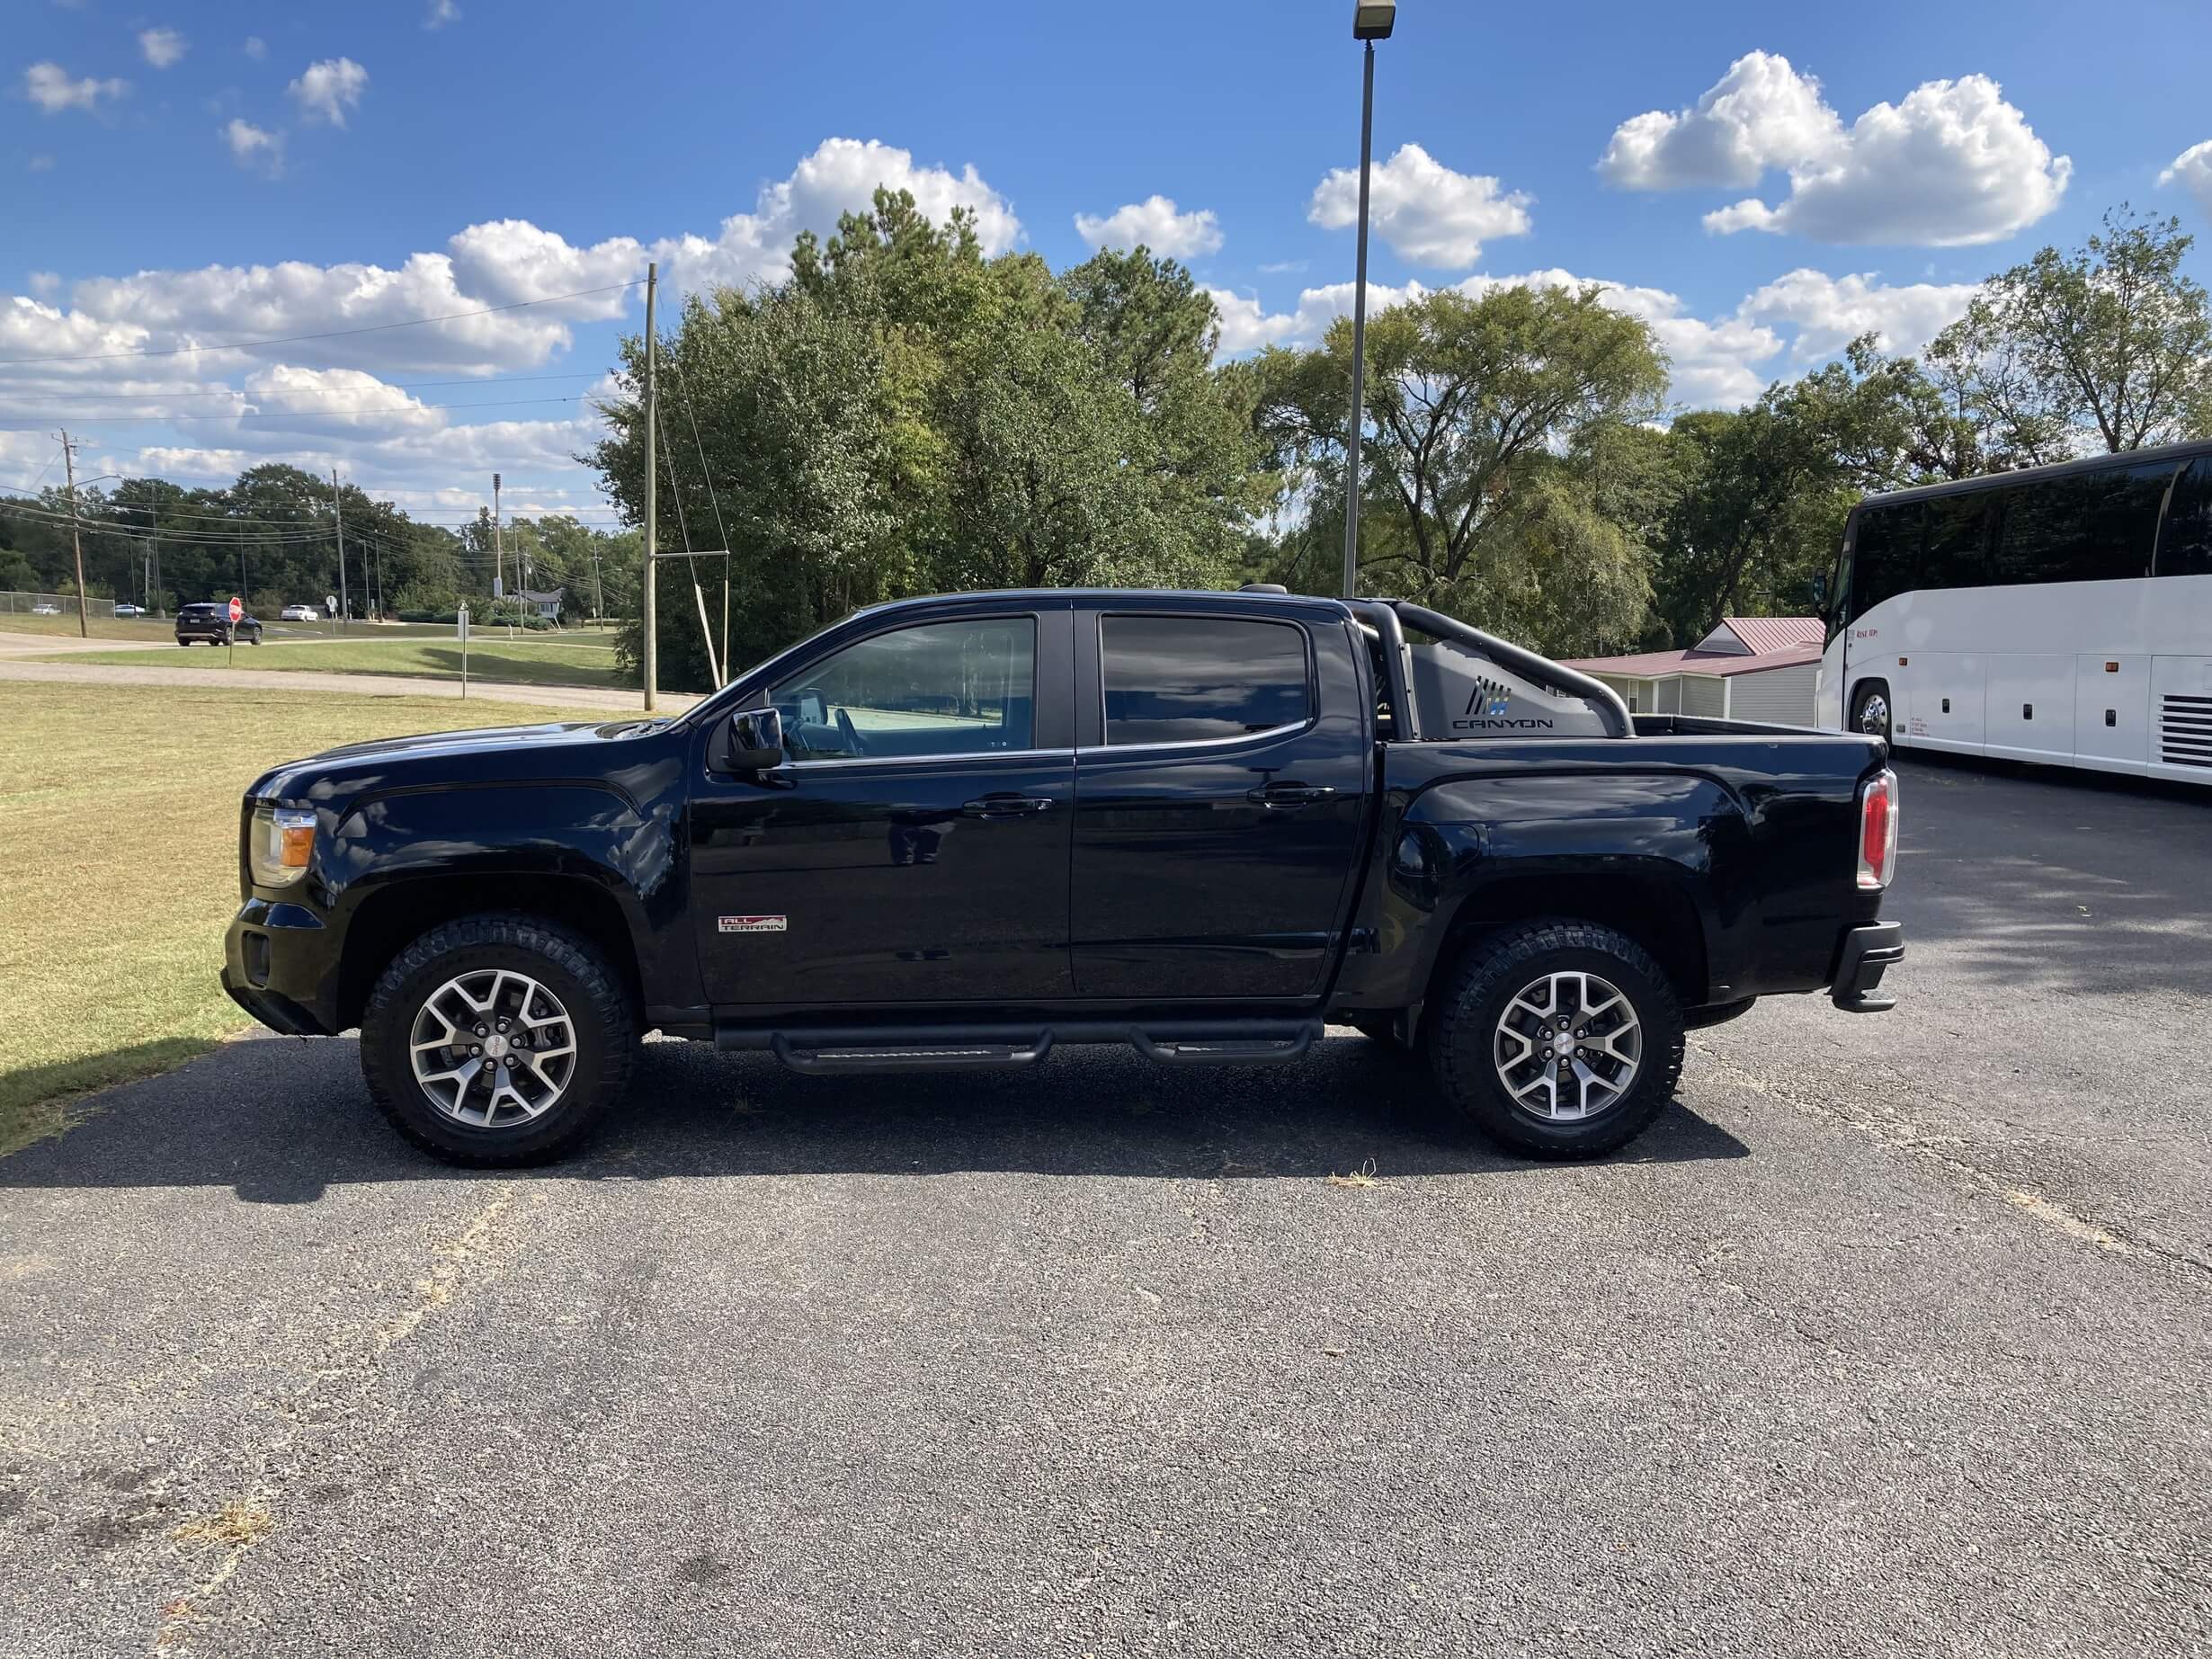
[770, 617, 1038, 761]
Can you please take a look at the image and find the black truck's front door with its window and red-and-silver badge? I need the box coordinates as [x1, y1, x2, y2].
[691, 611, 1075, 1009]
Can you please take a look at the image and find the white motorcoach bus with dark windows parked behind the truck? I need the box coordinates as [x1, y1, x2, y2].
[1818, 442, 2212, 783]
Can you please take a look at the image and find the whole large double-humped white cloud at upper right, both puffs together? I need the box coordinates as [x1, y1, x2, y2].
[1597, 51, 2073, 248]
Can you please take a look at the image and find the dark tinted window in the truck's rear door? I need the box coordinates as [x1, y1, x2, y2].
[1102, 617, 1307, 744]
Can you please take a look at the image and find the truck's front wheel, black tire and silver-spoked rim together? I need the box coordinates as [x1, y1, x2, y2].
[361, 915, 635, 1168]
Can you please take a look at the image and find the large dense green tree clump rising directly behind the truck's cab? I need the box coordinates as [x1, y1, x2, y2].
[593, 191, 1263, 688]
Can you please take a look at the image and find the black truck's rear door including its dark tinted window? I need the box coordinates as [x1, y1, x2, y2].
[1068, 600, 1374, 1002]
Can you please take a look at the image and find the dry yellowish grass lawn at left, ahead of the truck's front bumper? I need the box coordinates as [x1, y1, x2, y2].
[0, 681, 575, 1155]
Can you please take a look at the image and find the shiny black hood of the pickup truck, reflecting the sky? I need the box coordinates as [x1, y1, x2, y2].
[245, 719, 668, 803]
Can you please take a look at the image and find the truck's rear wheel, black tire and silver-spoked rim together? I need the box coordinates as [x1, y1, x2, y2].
[1429, 920, 1683, 1157]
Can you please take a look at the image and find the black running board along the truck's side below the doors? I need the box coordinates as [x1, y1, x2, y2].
[715, 1020, 1321, 1077]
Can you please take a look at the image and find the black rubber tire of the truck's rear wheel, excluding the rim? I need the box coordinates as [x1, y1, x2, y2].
[1424, 918, 1683, 1159]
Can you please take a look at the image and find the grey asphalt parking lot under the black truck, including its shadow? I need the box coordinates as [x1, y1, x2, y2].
[0, 765, 2212, 1659]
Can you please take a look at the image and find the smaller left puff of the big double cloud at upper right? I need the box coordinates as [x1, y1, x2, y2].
[1597, 51, 1842, 191]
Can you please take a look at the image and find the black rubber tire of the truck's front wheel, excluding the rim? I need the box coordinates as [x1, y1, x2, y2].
[361, 914, 637, 1170]
